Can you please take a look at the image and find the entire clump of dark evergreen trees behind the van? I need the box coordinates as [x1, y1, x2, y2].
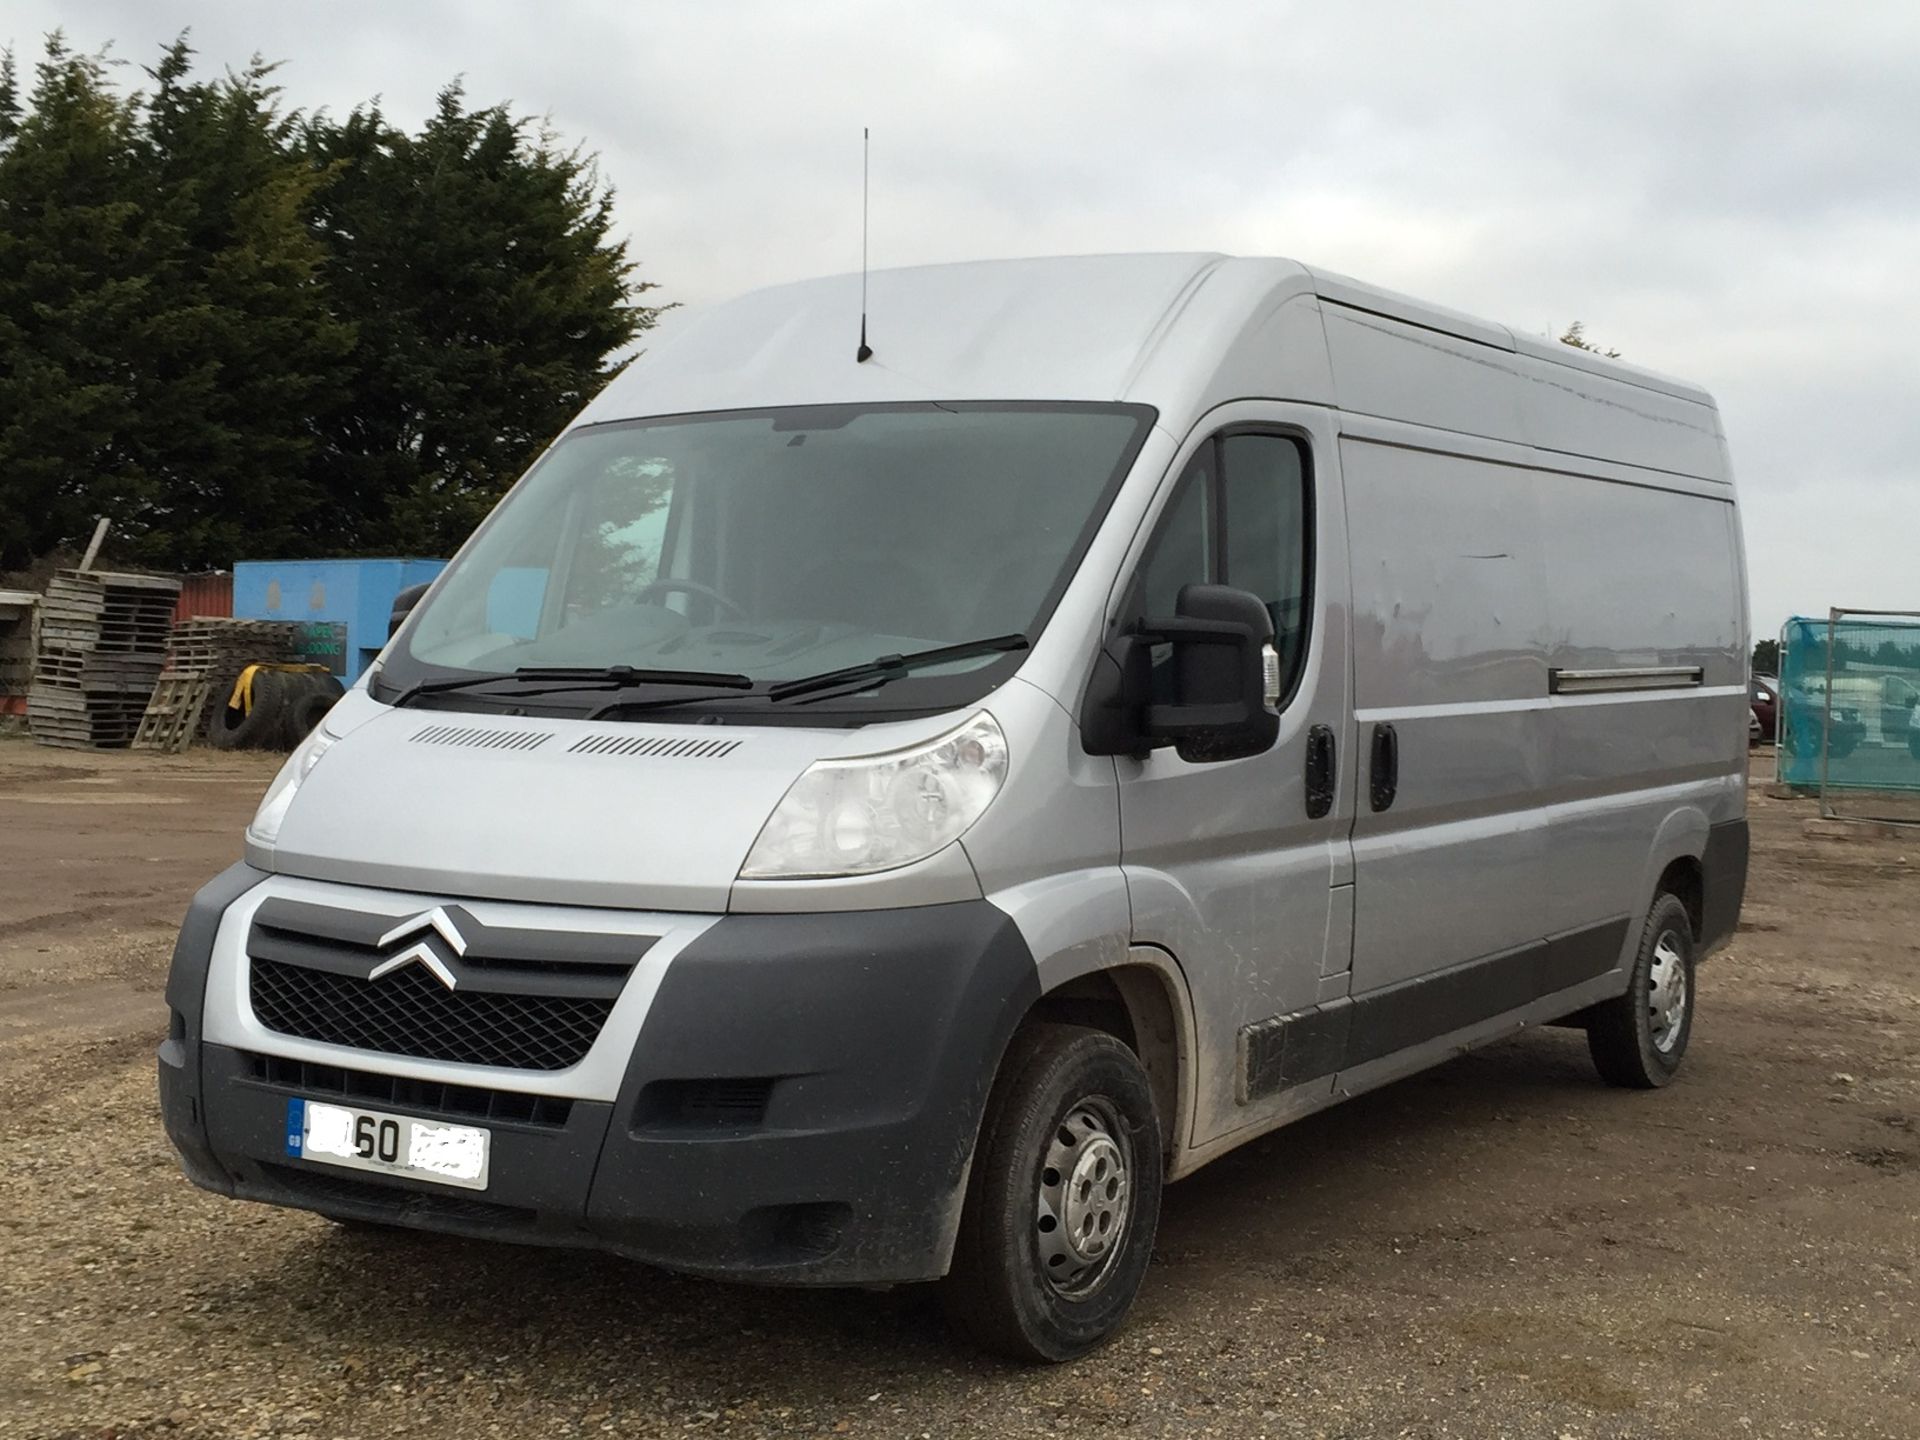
[0, 35, 655, 568]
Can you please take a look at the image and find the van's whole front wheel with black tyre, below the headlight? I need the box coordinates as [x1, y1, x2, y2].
[941, 1025, 1164, 1361]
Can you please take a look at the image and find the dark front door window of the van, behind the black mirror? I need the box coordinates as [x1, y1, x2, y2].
[1125, 432, 1311, 695]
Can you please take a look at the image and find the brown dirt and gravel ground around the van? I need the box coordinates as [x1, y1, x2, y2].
[0, 739, 1920, 1440]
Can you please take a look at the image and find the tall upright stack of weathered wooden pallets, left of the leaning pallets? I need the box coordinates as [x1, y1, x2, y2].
[27, 570, 180, 751]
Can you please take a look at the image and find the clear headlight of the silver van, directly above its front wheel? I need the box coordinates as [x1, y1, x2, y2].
[739, 710, 1006, 879]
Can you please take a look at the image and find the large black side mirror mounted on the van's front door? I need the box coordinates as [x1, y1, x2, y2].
[1081, 586, 1281, 764]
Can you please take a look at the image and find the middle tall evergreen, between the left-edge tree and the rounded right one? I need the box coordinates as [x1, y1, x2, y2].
[123, 38, 353, 568]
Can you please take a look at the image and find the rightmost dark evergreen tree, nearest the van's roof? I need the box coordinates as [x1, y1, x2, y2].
[307, 84, 657, 555]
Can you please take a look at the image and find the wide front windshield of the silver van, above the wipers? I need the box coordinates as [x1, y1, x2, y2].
[382, 403, 1152, 710]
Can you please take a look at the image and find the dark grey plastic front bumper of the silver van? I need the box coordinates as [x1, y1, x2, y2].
[159, 866, 1039, 1284]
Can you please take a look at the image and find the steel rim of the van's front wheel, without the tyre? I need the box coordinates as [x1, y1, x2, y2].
[1033, 1098, 1133, 1296]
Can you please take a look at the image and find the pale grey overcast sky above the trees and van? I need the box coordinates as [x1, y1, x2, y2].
[15, 0, 1920, 636]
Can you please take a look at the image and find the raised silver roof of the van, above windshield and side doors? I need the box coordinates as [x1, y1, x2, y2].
[582, 253, 1718, 472]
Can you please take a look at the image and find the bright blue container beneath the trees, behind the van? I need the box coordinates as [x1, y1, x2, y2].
[234, 559, 447, 685]
